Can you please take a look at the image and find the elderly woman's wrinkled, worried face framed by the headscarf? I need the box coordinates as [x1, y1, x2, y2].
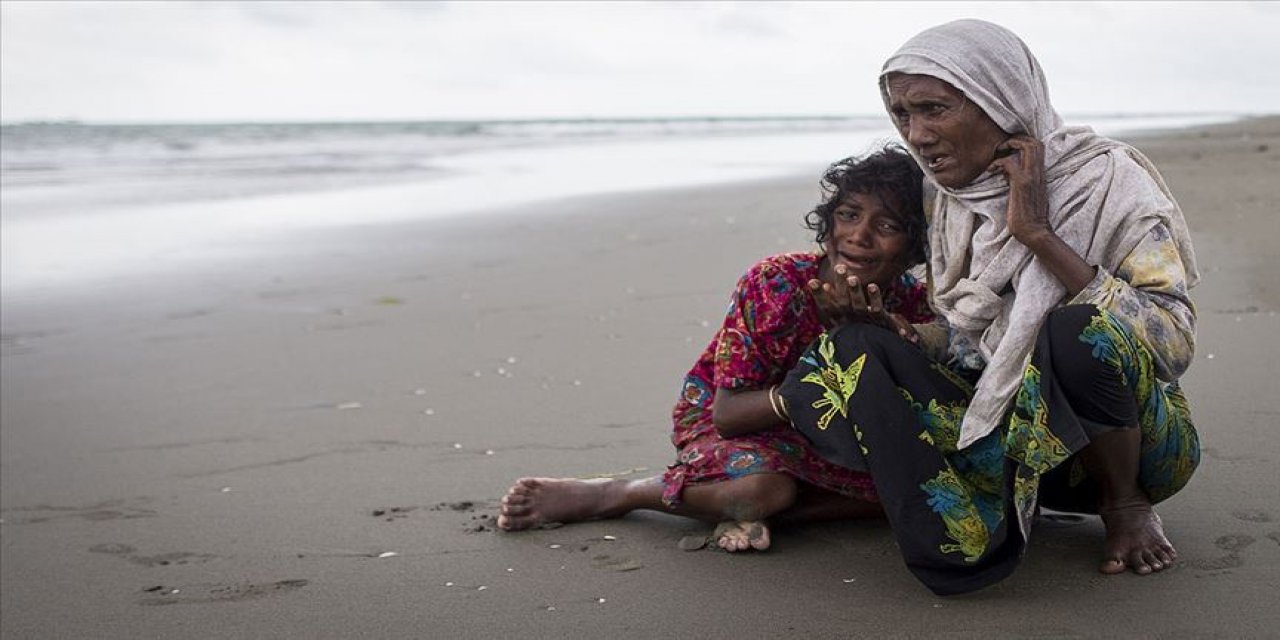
[886, 74, 1009, 188]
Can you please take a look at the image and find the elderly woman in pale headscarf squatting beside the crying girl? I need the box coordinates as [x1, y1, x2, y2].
[782, 20, 1199, 594]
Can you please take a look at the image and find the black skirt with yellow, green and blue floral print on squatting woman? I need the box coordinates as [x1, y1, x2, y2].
[782, 305, 1199, 595]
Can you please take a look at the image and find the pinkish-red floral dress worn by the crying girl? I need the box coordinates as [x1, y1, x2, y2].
[662, 253, 933, 506]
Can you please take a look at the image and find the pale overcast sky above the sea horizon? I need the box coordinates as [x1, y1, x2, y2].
[0, 0, 1280, 123]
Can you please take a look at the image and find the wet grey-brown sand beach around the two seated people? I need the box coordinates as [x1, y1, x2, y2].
[0, 118, 1280, 639]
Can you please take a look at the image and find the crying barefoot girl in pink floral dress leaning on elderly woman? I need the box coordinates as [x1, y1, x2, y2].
[498, 146, 931, 550]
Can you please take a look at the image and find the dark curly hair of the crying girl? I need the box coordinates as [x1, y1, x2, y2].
[804, 142, 925, 268]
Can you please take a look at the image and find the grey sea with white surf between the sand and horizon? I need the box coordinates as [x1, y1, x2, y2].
[0, 114, 1233, 293]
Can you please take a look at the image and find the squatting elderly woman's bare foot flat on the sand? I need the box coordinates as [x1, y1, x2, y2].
[1098, 502, 1178, 575]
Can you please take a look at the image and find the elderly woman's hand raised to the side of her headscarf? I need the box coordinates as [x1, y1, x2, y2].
[988, 134, 1055, 251]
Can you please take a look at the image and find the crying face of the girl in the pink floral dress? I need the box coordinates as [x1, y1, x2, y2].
[827, 193, 911, 291]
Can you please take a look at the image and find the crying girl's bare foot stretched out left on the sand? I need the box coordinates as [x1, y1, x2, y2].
[498, 477, 621, 531]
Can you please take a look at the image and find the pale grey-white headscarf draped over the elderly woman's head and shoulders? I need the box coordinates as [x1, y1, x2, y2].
[879, 20, 1199, 448]
